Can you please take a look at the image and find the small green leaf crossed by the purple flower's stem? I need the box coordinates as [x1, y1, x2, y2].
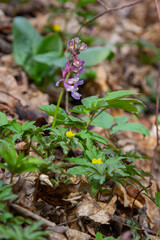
[39, 104, 67, 120]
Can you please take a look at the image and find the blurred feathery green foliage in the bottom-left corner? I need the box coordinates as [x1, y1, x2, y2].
[0, 181, 49, 240]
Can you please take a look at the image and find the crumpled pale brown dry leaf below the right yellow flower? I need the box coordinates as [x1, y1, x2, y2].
[76, 196, 117, 224]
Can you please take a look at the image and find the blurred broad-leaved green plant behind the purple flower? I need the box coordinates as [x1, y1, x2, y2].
[13, 17, 114, 86]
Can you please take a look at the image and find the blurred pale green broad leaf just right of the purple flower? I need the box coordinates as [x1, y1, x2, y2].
[80, 47, 112, 67]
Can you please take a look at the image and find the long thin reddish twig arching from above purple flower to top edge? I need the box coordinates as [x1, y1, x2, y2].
[75, 0, 144, 36]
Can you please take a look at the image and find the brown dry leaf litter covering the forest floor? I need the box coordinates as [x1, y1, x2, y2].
[0, 0, 160, 240]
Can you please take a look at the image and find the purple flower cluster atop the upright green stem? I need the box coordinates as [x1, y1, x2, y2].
[56, 37, 87, 100]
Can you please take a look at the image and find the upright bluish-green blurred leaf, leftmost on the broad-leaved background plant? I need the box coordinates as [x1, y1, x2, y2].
[13, 17, 42, 66]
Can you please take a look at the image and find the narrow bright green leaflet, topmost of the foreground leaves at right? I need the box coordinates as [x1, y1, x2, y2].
[104, 90, 137, 101]
